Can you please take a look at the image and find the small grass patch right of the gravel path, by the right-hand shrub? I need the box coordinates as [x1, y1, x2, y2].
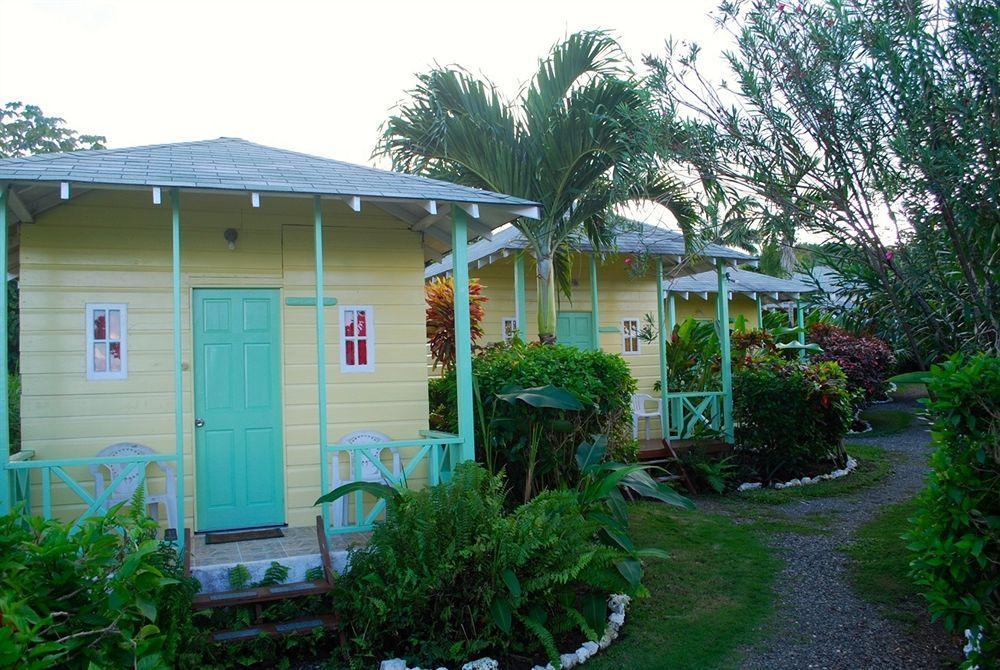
[841, 500, 927, 623]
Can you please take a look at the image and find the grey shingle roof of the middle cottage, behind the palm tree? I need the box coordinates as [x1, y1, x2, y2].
[424, 222, 755, 277]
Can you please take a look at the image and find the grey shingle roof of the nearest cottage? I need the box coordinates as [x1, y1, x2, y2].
[0, 137, 537, 206]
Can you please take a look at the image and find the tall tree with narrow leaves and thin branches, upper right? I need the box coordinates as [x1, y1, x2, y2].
[648, 0, 1000, 367]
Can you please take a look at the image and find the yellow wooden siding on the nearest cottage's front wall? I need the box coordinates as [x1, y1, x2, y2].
[20, 191, 427, 525]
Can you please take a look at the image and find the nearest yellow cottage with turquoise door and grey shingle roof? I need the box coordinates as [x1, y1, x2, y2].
[0, 138, 539, 556]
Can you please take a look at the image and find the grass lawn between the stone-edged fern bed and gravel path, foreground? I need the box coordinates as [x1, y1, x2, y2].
[586, 503, 780, 670]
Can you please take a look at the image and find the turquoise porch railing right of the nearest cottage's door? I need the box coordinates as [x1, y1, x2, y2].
[321, 430, 463, 534]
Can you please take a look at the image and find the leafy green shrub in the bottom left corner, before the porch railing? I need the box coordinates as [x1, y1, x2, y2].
[0, 506, 199, 668]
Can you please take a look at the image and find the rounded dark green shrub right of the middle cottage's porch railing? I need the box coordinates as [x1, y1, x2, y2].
[733, 354, 853, 483]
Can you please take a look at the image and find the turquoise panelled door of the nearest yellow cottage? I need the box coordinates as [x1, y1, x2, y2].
[193, 289, 285, 531]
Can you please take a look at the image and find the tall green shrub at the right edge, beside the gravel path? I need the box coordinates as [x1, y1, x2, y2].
[907, 354, 1000, 668]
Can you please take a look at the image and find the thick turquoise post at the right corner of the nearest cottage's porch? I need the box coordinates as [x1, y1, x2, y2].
[451, 205, 476, 461]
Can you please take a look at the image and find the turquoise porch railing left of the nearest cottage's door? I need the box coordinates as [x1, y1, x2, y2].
[6, 454, 184, 537]
